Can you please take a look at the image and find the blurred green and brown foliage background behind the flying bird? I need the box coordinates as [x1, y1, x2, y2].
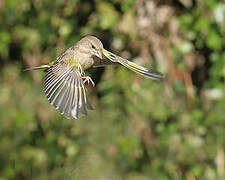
[0, 0, 225, 180]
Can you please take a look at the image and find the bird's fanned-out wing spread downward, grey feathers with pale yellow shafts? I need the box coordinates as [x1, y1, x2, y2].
[44, 62, 93, 118]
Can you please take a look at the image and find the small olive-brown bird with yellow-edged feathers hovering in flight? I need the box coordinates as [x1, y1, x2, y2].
[25, 36, 164, 119]
